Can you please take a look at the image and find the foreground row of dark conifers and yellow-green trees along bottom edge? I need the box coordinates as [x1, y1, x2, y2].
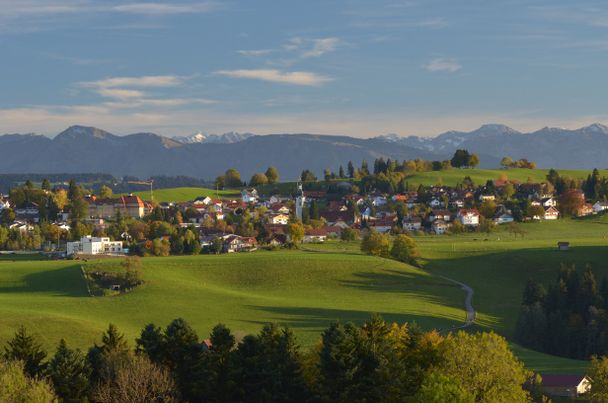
[0, 315, 534, 403]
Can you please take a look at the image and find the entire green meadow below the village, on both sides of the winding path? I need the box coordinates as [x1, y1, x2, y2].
[0, 216, 608, 373]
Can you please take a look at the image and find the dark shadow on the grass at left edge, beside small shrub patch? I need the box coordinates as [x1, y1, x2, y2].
[0, 265, 88, 297]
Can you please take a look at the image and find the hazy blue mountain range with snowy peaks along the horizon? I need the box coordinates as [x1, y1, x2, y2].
[0, 124, 608, 180]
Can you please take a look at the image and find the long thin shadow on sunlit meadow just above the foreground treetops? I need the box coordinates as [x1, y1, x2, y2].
[246, 306, 464, 329]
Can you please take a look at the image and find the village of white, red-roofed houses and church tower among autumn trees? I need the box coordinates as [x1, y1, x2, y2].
[0, 167, 608, 256]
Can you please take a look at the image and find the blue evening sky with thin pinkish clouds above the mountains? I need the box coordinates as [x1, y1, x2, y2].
[0, 0, 608, 137]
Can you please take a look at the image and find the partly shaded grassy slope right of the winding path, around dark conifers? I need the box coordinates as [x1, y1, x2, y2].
[417, 216, 608, 372]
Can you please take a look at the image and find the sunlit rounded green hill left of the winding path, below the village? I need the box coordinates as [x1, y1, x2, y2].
[0, 252, 464, 354]
